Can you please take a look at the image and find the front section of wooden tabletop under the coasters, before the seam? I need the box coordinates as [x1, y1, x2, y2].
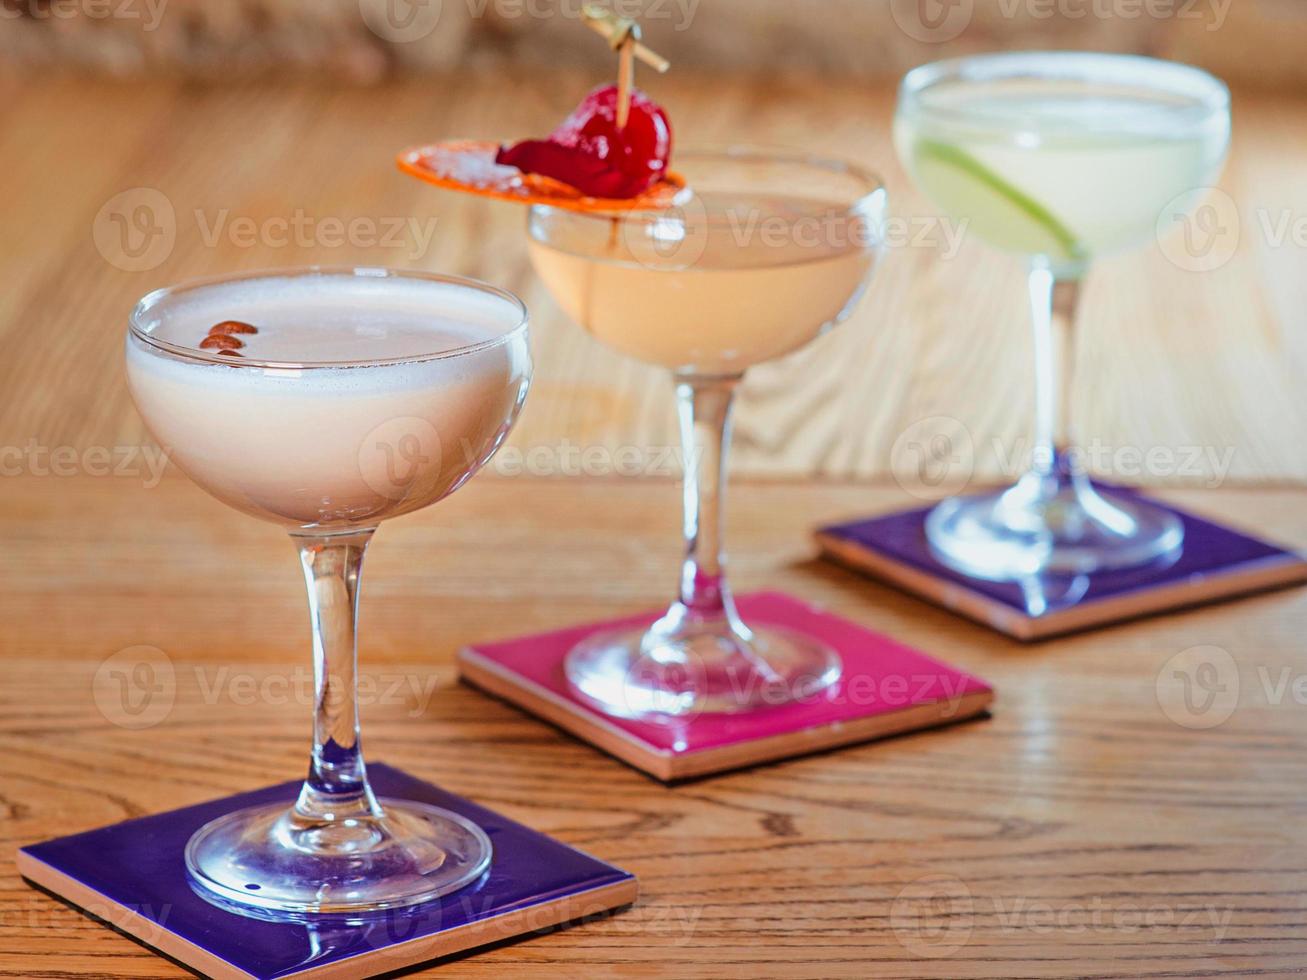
[0, 476, 1307, 980]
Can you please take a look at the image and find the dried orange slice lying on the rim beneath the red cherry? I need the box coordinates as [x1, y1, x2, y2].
[396, 140, 685, 212]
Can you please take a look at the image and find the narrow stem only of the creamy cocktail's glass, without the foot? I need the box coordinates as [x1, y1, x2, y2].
[291, 529, 382, 826]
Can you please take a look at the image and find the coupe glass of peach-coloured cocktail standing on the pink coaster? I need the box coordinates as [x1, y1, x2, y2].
[528, 148, 886, 717]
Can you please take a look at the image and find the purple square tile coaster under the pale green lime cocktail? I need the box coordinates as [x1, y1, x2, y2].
[817, 487, 1307, 640]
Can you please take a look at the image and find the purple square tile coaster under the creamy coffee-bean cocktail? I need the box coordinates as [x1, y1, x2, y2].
[18, 763, 638, 980]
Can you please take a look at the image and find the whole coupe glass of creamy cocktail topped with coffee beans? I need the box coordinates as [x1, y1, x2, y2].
[127, 269, 531, 919]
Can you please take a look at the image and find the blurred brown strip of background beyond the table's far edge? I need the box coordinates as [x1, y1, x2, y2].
[0, 0, 1307, 86]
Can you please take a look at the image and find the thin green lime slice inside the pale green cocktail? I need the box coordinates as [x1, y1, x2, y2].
[914, 140, 1087, 261]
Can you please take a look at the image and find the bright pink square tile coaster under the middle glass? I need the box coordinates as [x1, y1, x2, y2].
[459, 592, 993, 781]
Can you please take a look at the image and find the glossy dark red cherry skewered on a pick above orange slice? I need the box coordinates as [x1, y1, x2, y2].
[495, 85, 672, 199]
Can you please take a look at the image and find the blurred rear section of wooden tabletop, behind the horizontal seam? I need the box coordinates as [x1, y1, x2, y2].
[0, 67, 1307, 497]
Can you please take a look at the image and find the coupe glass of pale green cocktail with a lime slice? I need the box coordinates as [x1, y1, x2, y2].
[894, 52, 1230, 579]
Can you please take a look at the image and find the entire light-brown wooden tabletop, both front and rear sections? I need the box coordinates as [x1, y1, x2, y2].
[0, 73, 1307, 980]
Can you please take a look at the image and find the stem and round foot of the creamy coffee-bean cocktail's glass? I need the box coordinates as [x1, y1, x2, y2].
[186, 528, 491, 920]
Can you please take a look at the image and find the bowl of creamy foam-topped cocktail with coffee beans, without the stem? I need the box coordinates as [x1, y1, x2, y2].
[127, 274, 529, 527]
